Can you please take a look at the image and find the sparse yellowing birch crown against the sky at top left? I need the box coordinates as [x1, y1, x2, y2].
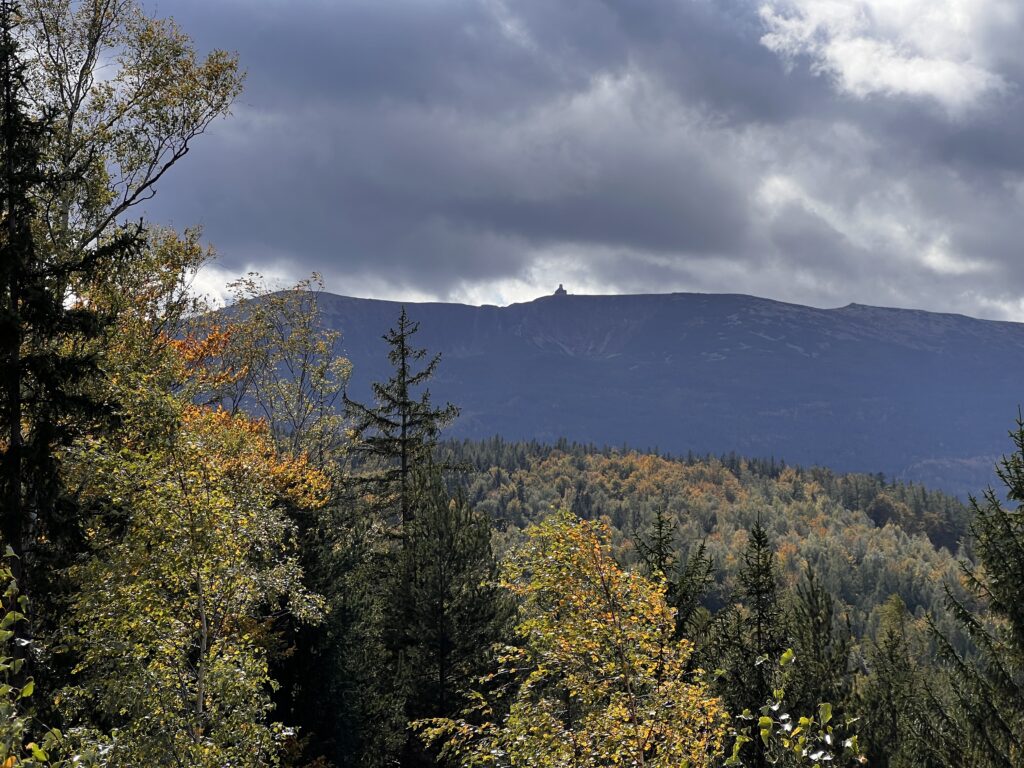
[22, 0, 242, 260]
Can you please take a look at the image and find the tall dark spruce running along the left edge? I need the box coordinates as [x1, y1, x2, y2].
[0, 0, 140, 647]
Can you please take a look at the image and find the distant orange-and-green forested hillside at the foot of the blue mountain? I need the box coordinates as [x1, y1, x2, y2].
[445, 438, 970, 634]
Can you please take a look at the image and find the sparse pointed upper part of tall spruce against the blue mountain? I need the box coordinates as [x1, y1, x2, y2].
[345, 306, 459, 525]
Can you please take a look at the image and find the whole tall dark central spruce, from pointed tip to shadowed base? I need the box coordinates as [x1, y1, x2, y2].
[331, 307, 466, 766]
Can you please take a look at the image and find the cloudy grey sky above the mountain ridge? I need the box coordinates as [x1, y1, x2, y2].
[147, 0, 1024, 321]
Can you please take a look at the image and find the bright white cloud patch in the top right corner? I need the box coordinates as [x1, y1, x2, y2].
[761, 0, 1017, 116]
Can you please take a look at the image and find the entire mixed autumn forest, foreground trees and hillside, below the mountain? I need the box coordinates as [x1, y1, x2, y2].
[0, 0, 1024, 768]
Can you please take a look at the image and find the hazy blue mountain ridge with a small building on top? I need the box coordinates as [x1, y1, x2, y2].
[321, 293, 1024, 494]
